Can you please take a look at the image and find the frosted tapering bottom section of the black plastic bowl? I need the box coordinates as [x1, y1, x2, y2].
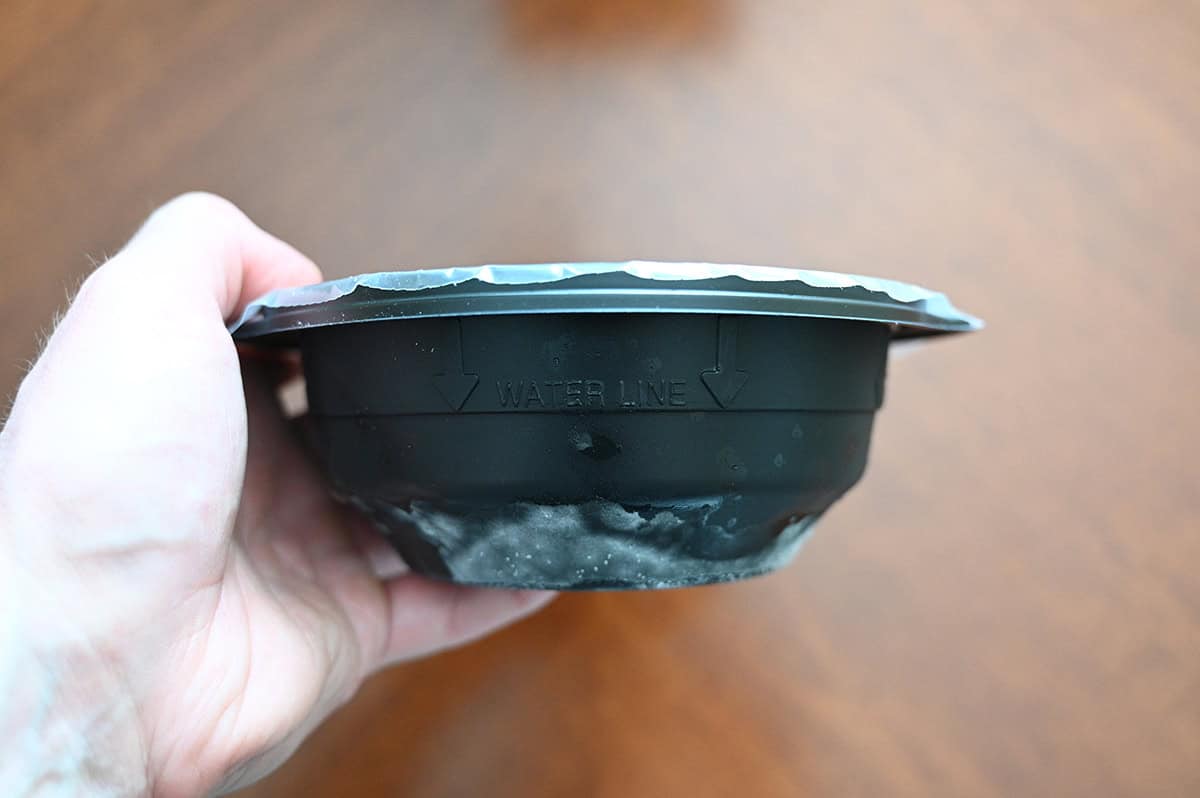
[346, 494, 820, 590]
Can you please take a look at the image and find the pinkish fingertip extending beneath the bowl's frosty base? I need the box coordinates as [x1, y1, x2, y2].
[379, 574, 556, 667]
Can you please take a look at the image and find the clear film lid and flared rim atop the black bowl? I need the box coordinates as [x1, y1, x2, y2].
[229, 260, 983, 343]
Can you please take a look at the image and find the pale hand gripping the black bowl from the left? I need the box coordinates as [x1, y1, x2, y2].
[0, 194, 551, 796]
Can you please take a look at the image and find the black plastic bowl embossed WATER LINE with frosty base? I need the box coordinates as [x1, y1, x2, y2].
[235, 266, 978, 589]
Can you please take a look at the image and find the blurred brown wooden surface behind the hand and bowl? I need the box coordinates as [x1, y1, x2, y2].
[0, 0, 1200, 798]
